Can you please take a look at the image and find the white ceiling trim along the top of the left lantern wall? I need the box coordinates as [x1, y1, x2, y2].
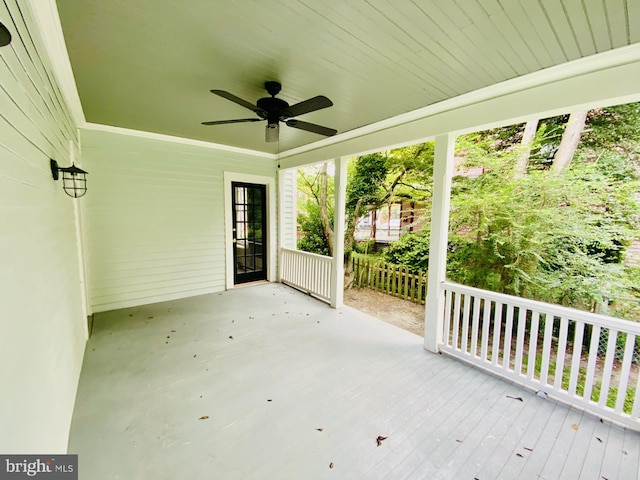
[26, 0, 86, 127]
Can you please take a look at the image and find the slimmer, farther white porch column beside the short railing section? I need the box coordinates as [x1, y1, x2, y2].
[331, 157, 347, 308]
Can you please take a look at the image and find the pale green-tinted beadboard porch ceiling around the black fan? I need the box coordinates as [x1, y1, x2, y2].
[57, 0, 640, 153]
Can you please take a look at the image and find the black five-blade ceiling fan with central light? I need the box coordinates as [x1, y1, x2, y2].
[202, 82, 338, 142]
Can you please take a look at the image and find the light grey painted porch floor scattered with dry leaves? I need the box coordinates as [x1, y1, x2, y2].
[69, 284, 640, 480]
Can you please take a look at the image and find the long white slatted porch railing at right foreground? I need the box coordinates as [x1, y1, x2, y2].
[440, 282, 640, 429]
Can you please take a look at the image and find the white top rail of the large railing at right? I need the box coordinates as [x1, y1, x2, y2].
[441, 281, 640, 335]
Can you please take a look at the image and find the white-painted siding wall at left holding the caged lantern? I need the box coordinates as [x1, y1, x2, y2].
[0, 0, 87, 453]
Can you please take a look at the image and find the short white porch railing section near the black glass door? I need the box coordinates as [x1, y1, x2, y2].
[280, 248, 333, 302]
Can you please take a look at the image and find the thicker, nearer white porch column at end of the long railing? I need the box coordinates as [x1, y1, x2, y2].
[424, 133, 456, 353]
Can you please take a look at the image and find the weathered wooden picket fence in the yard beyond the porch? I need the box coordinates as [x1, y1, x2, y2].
[353, 257, 427, 305]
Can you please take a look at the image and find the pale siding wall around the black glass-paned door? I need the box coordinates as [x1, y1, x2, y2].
[81, 129, 276, 312]
